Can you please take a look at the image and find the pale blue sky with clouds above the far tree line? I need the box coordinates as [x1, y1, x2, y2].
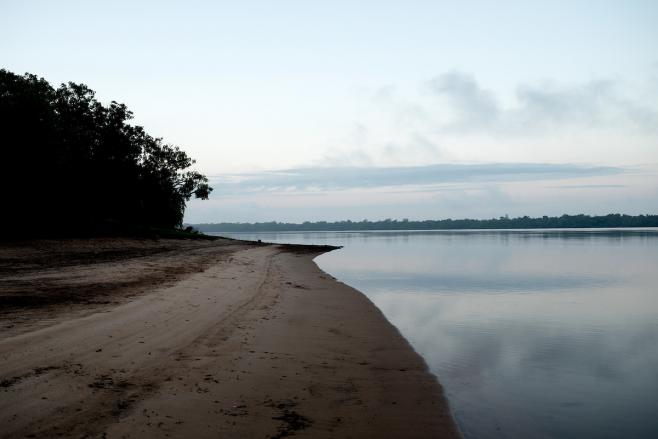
[0, 0, 658, 223]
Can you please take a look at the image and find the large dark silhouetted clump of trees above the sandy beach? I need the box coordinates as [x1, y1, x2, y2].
[0, 69, 212, 235]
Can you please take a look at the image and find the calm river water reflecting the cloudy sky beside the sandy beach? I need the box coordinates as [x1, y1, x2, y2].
[215, 229, 658, 439]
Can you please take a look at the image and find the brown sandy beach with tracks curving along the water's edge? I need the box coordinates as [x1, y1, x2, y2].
[0, 239, 459, 438]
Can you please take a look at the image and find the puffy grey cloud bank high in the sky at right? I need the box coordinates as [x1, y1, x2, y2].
[420, 71, 658, 136]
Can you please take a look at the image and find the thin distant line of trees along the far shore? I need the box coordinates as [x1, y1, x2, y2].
[193, 213, 658, 232]
